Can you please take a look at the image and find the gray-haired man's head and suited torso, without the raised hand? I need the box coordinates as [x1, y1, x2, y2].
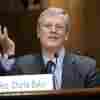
[0, 7, 96, 89]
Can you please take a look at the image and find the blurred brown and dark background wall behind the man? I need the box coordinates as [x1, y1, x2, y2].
[0, 0, 100, 71]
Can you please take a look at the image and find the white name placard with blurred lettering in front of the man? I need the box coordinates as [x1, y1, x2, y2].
[0, 74, 53, 93]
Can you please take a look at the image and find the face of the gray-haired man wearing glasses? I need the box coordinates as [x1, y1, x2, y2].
[38, 16, 67, 48]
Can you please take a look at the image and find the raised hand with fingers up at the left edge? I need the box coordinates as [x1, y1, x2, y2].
[0, 25, 15, 55]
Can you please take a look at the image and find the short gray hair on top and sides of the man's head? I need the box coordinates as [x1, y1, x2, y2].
[37, 7, 71, 32]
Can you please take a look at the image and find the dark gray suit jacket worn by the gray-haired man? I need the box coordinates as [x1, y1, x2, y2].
[16, 54, 96, 89]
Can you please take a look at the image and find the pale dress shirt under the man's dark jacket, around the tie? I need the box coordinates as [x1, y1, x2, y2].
[42, 47, 65, 89]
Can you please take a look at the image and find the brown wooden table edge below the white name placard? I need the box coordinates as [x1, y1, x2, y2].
[0, 87, 100, 97]
